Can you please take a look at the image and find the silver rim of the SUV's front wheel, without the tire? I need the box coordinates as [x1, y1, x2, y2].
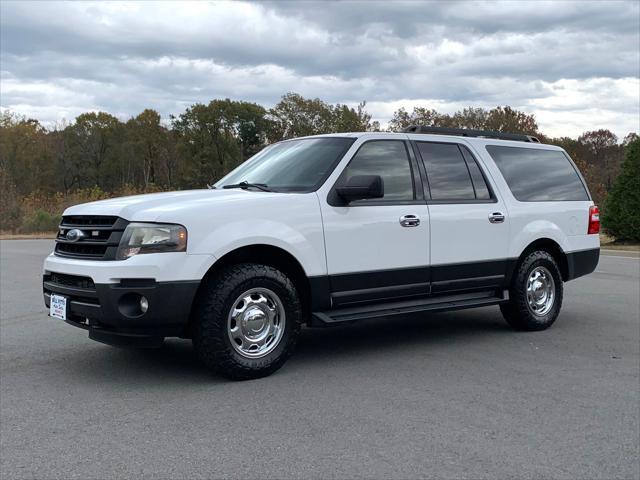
[227, 288, 286, 358]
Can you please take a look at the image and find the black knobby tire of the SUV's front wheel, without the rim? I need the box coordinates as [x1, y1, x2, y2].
[192, 263, 303, 380]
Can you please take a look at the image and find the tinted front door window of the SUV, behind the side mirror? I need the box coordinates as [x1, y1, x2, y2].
[343, 140, 415, 202]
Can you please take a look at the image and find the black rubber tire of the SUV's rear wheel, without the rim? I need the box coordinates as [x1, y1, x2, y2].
[500, 250, 563, 331]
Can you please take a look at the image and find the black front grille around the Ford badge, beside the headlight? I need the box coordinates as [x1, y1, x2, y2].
[55, 215, 128, 260]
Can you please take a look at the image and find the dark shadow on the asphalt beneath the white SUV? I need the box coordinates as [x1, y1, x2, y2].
[60, 308, 511, 387]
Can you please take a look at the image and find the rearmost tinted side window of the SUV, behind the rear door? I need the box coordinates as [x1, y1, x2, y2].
[487, 145, 589, 202]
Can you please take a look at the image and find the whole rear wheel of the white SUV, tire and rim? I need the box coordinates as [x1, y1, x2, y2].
[500, 250, 563, 331]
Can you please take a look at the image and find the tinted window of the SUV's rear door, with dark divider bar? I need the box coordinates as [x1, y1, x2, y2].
[416, 142, 491, 201]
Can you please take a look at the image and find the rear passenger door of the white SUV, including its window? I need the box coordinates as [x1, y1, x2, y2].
[413, 140, 509, 294]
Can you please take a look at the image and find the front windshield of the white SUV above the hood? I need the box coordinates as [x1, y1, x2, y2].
[215, 137, 355, 191]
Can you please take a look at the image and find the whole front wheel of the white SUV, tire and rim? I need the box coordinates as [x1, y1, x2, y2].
[192, 264, 302, 380]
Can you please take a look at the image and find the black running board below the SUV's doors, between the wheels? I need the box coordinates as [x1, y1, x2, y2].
[310, 290, 509, 327]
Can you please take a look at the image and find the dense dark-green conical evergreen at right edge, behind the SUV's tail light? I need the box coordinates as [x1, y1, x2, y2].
[602, 139, 640, 242]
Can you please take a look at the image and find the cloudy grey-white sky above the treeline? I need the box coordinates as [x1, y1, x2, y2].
[0, 0, 640, 136]
